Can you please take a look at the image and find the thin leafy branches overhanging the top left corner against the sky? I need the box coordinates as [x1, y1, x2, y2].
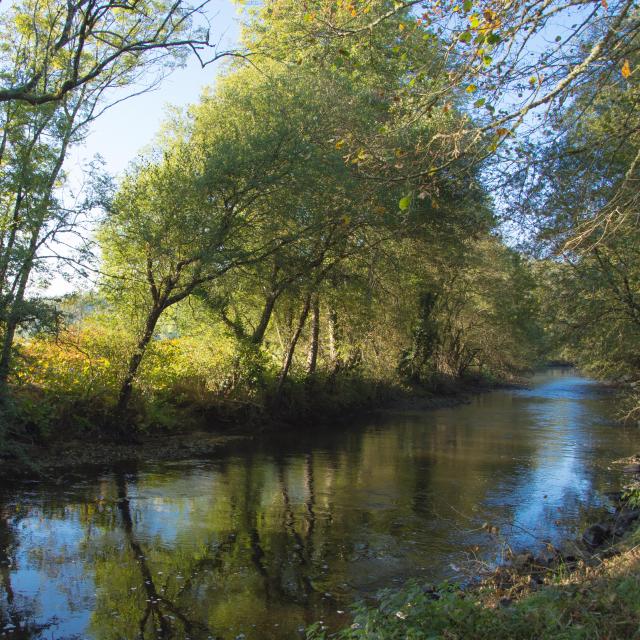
[0, 0, 229, 105]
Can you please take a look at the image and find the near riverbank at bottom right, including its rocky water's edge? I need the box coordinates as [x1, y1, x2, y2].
[307, 456, 640, 640]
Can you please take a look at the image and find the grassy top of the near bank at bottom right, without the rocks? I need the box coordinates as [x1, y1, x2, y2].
[307, 530, 640, 640]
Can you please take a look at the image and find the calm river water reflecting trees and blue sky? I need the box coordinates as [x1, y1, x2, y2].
[0, 370, 640, 640]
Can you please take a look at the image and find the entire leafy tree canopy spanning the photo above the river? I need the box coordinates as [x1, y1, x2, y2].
[0, 0, 638, 434]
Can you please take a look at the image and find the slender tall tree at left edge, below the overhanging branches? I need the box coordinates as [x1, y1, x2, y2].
[0, 95, 89, 388]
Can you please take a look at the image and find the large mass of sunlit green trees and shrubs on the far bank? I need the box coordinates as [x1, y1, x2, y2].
[2, 0, 539, 440]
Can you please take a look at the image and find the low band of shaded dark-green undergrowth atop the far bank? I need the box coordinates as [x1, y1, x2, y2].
[0, 344, 498, 450]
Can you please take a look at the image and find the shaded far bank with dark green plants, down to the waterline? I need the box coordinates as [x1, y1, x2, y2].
[0, 375, 503, 478]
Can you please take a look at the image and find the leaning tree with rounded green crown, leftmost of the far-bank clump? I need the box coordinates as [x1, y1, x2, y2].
[102, 69, 344, 414]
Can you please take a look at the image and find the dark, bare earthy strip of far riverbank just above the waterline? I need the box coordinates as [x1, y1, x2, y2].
[0, 378, 516, 481]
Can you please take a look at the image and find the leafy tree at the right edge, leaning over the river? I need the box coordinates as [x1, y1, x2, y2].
[517, 38, 640, 411]
